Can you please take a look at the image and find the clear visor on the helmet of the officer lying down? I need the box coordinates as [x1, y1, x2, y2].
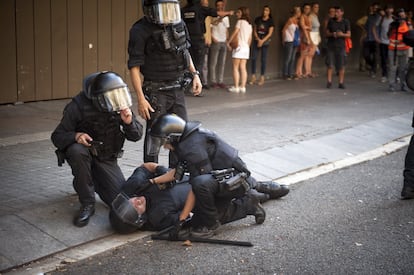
[112, 193, 145, 228]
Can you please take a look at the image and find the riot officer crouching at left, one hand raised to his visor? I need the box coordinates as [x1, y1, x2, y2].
[51, 72, 143, 227]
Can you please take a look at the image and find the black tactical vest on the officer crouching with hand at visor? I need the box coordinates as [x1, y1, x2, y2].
[73, 93, 125, 160]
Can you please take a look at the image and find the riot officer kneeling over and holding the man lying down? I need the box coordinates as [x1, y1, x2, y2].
[148, 115, 289, 237]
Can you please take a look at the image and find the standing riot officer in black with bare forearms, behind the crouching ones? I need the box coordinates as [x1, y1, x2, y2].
[128, 0, 202, 162]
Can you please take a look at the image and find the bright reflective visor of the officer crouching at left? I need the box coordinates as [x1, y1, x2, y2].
[102, 87, 132, 112]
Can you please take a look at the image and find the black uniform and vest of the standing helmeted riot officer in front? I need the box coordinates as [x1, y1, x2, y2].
[128, 17, 191, 162]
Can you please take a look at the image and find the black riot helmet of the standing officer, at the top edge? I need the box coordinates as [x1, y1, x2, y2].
[142, 0, 181, 25]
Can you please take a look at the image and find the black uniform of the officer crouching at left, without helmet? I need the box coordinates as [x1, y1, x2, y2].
[51, 92, 143, 205]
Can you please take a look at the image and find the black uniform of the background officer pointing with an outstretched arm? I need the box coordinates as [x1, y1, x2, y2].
[181, 3, 218, 81]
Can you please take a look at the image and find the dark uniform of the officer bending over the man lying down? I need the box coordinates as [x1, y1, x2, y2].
[174, 125, 257, 227]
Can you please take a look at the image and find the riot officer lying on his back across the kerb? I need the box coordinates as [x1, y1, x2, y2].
[109, 163, 269, 237]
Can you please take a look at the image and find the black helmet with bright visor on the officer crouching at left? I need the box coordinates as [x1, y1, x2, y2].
[83, 71, 132, 112]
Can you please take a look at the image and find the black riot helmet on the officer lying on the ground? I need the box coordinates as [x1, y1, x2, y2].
[109, 193, 147, 234]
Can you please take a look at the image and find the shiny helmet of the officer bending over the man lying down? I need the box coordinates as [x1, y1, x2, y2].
[147, 114, 201, 156]
